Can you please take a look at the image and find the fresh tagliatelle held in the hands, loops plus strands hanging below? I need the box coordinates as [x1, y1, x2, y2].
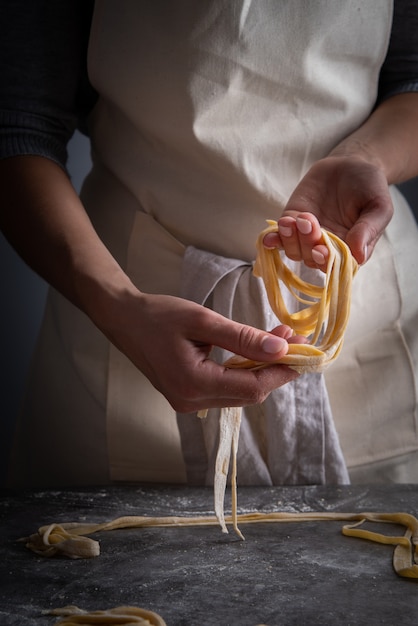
[209, 221, 358, 538]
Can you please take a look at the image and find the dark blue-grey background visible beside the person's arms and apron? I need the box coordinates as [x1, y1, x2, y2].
[0, 132, 418, 483]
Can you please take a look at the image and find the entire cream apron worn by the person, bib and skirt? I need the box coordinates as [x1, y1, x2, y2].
[8, 0, 418, 484]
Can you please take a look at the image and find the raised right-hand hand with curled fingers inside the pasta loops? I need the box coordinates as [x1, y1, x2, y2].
[264, 156, 393, 270]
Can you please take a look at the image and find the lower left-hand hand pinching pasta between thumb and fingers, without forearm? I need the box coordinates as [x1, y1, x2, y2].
[99, 292, 306, 413]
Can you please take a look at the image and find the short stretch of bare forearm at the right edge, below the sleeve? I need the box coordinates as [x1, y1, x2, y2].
[330, 93, 418, 184]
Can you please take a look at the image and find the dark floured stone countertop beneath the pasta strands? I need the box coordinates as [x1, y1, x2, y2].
[0, 485, 418, 626]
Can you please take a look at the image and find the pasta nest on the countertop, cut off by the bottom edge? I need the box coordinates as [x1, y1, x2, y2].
[47, 606, 167, 626]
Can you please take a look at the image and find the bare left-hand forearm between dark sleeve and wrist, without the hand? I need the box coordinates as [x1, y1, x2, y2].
[0, 156, 136, 323]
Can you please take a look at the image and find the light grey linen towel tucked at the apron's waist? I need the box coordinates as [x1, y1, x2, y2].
[177, 246, 349, 485]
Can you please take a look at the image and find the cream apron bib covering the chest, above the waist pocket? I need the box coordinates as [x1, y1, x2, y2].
[89, 0, 392, 260]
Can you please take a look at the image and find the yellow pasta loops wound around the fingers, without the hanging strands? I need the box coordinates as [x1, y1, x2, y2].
[225, 220, 358, 373]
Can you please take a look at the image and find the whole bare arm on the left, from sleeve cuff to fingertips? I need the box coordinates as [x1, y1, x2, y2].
[0, 157, 297, 413]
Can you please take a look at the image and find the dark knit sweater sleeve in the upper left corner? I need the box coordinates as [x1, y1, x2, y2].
[0, 0, 94, 168]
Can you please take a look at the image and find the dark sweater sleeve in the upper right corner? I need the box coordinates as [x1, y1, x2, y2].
[378, 0, 418, 102]
